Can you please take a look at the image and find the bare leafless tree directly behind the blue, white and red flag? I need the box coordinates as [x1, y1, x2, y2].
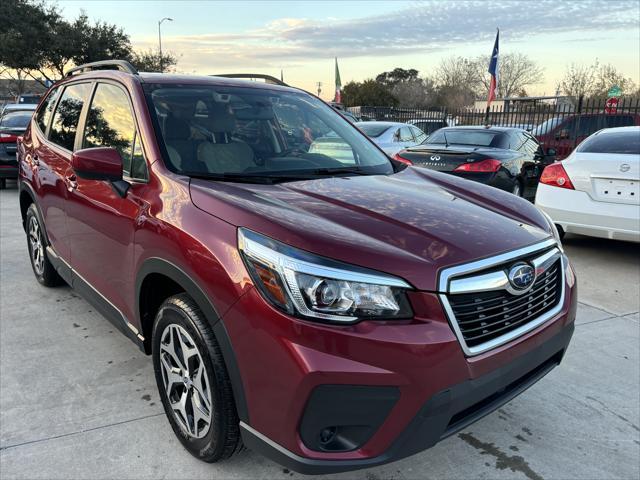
[475, 53, 544, 98]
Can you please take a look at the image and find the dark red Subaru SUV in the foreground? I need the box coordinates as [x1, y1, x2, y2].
[18, 62, 577, 473]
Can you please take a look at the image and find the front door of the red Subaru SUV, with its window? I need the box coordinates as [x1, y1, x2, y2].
[67, 81, 148, 318]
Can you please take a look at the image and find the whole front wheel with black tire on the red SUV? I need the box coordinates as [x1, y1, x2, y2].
[152, 294, 242, 463]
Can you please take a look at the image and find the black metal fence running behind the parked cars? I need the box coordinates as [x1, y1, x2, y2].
[348, 97, 640, 138]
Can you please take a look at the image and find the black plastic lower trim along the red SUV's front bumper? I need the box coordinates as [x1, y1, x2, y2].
[240, 322, 574, 475]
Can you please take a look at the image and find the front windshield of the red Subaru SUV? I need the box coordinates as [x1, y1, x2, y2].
[147, 85, 394, 181]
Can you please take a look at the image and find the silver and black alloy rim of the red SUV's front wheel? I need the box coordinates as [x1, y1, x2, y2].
[160, 324, 212, 438]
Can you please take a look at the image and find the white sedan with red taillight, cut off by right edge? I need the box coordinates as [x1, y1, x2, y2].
[536, 127, 640, 242]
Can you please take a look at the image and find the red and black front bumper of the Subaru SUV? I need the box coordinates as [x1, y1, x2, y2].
[223, 256, 577, 474]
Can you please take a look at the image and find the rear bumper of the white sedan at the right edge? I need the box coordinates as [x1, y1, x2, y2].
[536, 184, 640, 242]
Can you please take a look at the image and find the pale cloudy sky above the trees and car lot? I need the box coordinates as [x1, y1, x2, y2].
[55, 0, 640, 99]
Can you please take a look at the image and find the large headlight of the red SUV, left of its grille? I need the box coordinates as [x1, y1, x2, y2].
[238, 228, 413, 323]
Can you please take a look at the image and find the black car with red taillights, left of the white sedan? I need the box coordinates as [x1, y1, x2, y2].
[395, 126, 554, 200]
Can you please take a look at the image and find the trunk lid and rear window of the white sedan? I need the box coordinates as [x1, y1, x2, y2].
[563, 129, 640, 205]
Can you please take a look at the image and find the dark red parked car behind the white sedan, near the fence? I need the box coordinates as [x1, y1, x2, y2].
[531, 113, 640, 160]
